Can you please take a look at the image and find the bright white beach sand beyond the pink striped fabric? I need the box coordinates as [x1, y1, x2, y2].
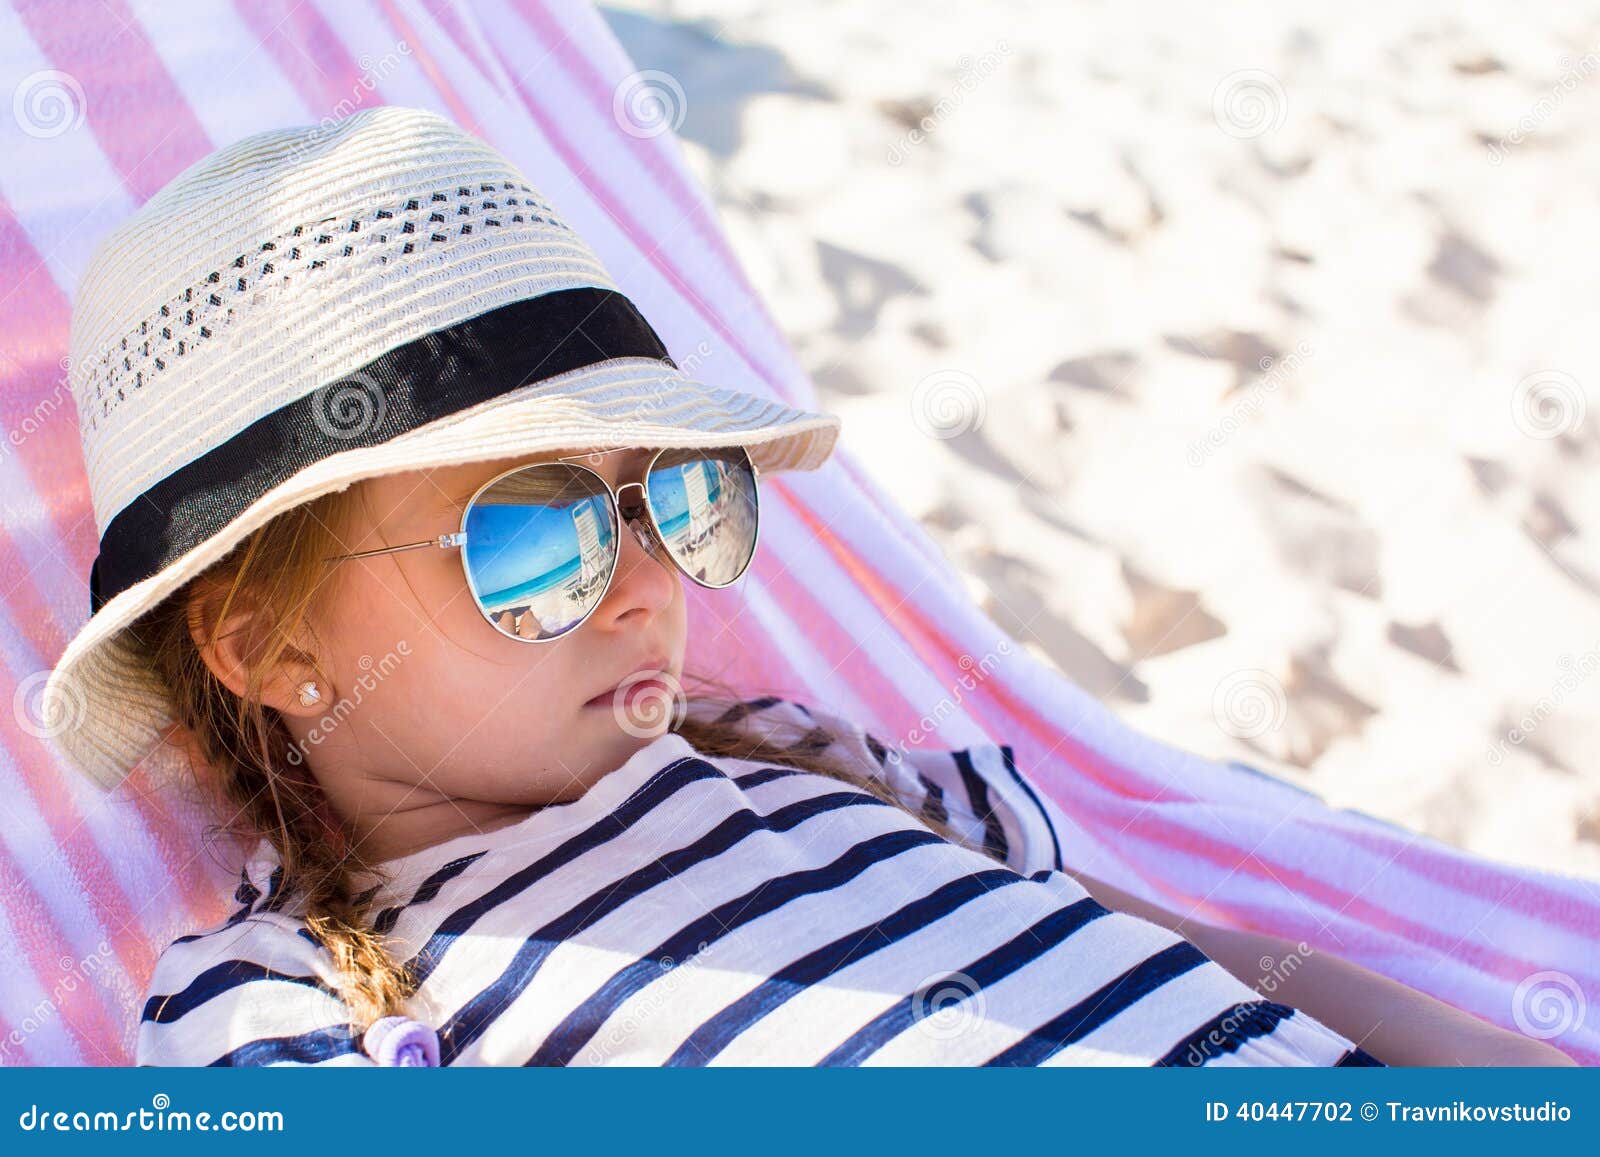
[605, 0, 1600, 880]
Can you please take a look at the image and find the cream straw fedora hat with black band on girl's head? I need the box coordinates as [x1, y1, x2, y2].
[40, 106, 840, 787]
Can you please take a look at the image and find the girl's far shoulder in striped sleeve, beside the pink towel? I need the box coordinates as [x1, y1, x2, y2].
[690, 695, 1062, 874]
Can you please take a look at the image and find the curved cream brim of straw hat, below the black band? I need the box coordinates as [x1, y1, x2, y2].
[42, 357, 840, 789]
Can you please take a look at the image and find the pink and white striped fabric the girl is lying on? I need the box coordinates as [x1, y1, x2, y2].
[0, 0, 1600, 1064]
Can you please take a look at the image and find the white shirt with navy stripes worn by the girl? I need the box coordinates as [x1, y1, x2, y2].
[134, 698, 1376, 1066]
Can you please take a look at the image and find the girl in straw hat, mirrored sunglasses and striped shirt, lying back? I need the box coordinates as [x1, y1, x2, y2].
[46, 107, 1566, 1066]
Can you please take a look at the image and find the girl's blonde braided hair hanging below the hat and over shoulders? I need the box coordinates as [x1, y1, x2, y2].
[134, 486, 992, 1031]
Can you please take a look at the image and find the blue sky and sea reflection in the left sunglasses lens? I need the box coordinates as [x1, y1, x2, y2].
[467, 496, 614, 597]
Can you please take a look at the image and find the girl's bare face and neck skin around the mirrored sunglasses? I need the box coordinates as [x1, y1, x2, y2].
[280, 450, 686, 859]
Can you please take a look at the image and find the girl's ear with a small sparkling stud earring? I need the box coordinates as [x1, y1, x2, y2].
[186, 578, 333, 717]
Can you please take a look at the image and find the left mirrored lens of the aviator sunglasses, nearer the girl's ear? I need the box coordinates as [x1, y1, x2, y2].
[462, 462, 618, 639]
